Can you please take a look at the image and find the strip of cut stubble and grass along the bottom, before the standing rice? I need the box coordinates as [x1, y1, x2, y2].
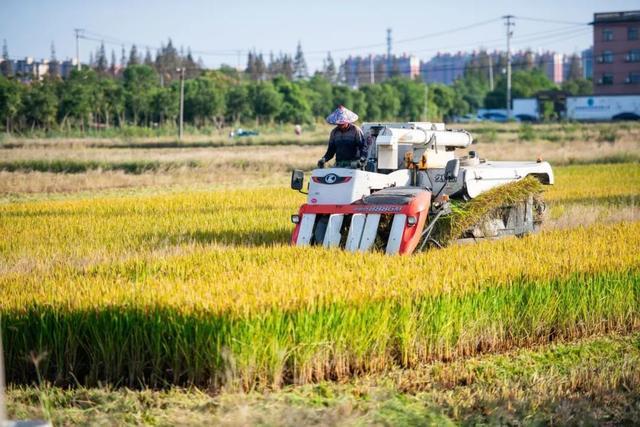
[8, 334, 640, 425]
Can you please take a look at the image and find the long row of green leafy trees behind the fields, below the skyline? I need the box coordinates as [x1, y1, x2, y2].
[0, 54, 591, 131]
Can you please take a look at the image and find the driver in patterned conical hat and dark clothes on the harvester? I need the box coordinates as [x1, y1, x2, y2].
[318, 105, 368, 169]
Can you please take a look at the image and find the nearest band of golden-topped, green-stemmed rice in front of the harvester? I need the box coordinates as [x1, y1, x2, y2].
[0, 223, 640, 389]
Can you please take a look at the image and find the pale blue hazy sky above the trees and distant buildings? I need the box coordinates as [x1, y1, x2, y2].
[0, 0, 640, 71]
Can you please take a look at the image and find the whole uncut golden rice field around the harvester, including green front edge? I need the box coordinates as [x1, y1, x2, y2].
[0, 159, 640, 390]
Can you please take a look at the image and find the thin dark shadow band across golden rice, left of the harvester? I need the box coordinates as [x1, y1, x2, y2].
[142, 228, 292, 247]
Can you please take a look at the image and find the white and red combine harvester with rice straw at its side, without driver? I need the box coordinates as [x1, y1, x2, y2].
[291, 122, 554, 254]
